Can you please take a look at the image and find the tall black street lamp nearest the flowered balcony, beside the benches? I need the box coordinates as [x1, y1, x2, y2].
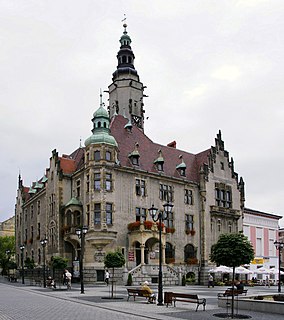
[148, 202, 173, 306]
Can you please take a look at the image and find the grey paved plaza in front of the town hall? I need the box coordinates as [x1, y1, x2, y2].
[0, 277, 283, 320]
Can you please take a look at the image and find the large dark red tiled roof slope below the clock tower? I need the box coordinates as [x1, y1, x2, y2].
[110, 115, 207, 182]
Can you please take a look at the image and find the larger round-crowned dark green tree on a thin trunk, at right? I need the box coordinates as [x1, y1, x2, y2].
[210, 233, 254, 318]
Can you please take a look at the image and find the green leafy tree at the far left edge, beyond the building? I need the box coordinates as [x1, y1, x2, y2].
[0, 236, 15, 275]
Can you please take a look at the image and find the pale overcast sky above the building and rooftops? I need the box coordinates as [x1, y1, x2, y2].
[0, 0, 284, 226]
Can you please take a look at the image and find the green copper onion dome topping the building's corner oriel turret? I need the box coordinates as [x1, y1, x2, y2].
[85, 101, 117, 147]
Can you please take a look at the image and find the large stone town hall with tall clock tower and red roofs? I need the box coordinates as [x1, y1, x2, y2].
[16, 26, 244, 284]
